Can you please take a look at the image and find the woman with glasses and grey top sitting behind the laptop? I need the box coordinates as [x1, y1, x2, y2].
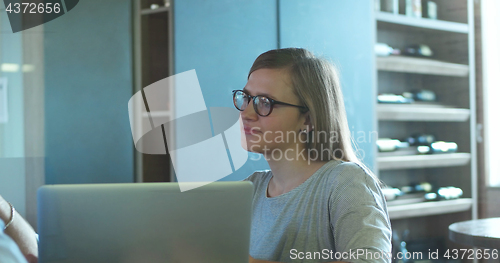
[233, 48, 391, 262]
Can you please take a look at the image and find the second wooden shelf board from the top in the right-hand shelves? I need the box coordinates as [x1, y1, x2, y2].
[377, 56, 469, 77]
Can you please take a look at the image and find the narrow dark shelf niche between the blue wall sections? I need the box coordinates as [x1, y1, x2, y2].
[133, 0, 175, 182]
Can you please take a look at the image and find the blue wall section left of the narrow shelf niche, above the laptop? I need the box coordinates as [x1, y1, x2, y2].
[44, 0, 134, 184]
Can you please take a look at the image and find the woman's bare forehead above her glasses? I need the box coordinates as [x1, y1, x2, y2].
[244, 68, 295, 100]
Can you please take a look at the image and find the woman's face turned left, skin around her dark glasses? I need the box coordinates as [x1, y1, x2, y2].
[240, 69, 307, 157]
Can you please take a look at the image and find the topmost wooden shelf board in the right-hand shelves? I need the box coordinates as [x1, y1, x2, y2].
[375, 12, 469, 34]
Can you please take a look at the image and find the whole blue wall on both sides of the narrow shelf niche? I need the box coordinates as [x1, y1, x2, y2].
[45, 0, 376, 184]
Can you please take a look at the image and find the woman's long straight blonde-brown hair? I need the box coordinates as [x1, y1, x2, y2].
[248, 48, 380, 183]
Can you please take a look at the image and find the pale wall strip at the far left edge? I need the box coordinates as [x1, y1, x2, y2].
[0, 2, 45, 228]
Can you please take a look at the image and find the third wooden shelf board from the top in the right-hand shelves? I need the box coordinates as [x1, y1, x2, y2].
[377, 104, 470, 122]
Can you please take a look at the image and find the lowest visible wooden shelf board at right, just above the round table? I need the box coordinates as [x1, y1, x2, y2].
[387, 198, 472, 220]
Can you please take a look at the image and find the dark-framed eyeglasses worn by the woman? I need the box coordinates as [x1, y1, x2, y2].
[233, 90, 308, 117]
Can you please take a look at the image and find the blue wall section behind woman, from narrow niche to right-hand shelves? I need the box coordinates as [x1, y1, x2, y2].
[174, 0, 376, 180]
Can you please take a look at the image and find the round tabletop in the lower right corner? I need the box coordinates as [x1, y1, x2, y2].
[448, 217, 500, 248]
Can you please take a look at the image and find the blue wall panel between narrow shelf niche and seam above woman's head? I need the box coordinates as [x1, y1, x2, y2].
[174, 0, 278, 180]
